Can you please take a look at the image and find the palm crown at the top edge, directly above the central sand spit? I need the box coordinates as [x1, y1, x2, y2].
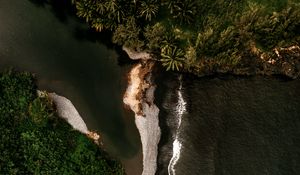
[140, 0, 159, 21]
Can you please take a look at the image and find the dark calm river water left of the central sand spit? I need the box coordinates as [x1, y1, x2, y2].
[0, 0, 142, 174]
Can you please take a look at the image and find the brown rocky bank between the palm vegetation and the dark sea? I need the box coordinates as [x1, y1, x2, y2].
[180, 45, 300, 79]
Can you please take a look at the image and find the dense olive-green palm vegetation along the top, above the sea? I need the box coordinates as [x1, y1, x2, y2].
[72, 0, 300, 72]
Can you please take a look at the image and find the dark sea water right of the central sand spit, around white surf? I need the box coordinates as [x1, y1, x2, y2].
[157, 75, 300, 175]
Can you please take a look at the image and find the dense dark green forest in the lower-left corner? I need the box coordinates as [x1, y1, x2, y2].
[0, 71, 124, 175]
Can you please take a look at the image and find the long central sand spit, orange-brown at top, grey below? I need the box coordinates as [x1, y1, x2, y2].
[123, 62, 161, 175]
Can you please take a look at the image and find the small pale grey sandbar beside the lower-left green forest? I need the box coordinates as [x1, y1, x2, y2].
[38, 91, 100, 143]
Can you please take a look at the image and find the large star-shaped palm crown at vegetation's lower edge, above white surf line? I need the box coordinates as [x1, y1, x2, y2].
[160, 46, 184, 71]
